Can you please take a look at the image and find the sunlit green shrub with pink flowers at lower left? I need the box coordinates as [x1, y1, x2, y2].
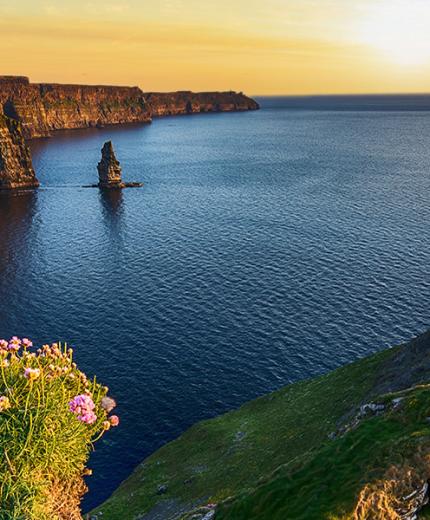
[0, 337, 119, 520]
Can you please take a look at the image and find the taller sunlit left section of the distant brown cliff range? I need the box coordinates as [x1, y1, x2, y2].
[0, 76, 151, 139]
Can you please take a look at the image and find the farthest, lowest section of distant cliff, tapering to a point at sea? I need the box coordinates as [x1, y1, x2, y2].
[145, 91, 260, 117]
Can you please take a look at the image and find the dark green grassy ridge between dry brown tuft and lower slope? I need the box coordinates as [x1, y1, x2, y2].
[216, 387, 430, 520]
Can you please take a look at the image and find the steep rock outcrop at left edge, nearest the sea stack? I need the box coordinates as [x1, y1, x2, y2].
[0, 114, 39, 189]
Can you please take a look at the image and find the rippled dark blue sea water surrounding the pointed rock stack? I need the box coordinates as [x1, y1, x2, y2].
[0, 99, 430, 507]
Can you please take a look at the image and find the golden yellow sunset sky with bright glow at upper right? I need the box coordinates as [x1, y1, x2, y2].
[0, 0, 430, 95]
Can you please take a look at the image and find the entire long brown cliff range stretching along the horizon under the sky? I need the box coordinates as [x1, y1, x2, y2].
[0, 76, 259, 139]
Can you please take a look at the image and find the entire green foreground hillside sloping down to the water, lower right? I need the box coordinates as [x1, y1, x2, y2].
[91, 332, 430, 520]
